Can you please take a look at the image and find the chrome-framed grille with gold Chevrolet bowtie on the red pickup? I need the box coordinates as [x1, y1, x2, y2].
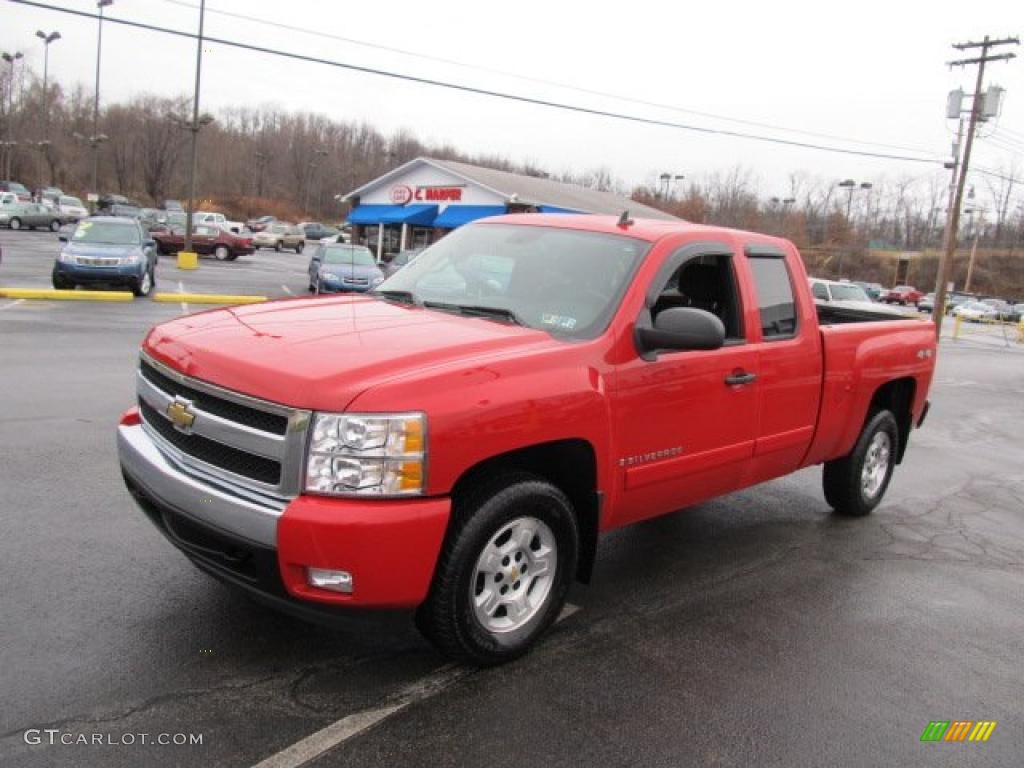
[136, 354, 309, 503]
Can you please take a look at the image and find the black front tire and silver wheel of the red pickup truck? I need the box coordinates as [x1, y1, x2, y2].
[416, 472, 580, 666]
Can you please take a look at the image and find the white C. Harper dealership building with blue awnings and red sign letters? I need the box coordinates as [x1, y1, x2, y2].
[343, 158, 673, 260]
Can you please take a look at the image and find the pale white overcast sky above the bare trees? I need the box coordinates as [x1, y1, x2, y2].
[0, 0, 1024, 202]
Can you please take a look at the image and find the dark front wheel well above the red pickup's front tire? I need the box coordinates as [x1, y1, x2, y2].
[452, 439, 601, 583]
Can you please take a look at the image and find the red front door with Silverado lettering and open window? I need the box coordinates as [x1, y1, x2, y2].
[611, 243, 759, 525]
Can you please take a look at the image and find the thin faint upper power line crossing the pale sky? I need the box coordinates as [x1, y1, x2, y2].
[148, 0, 940, 159]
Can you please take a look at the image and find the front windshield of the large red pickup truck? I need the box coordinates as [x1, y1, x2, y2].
[377, 224, 649, 338]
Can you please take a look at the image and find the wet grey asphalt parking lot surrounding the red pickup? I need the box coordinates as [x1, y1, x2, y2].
[0, 225, 1024, 768]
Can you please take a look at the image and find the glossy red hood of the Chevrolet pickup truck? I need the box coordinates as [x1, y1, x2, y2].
[142, 296, 559, 411]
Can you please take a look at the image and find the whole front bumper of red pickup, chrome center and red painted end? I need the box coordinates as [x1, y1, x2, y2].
[118, 424, 451, 618]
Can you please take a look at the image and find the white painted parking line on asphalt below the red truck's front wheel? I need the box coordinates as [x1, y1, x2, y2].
[247, 603, 580, 768]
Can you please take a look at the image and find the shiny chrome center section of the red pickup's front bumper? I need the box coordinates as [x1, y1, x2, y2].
[118, 425, 286, 548]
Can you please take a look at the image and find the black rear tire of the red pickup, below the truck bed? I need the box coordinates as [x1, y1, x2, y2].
[821, 411, 899, 517]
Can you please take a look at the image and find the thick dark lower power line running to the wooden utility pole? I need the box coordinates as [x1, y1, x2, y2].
[10, 0, 941, 164]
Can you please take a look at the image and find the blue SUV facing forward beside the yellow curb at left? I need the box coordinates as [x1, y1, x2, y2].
[52, 216, 158, 296]
